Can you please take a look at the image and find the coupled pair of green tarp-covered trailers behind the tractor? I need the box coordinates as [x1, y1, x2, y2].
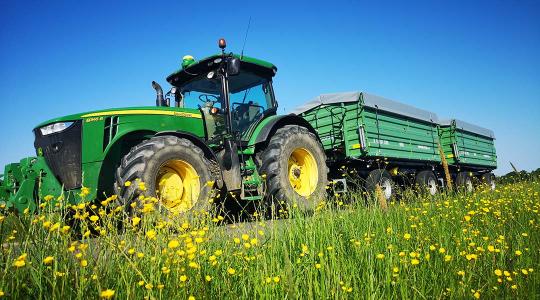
[293, 92, 496, 198]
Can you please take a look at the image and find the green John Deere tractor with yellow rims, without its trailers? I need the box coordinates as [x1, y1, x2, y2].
[0, 39, 328, 213]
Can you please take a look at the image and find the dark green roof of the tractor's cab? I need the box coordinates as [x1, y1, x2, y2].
[167, 53, 277, 87]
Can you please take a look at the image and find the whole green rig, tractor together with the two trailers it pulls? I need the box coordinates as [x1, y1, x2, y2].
[0, 40, 496, 213]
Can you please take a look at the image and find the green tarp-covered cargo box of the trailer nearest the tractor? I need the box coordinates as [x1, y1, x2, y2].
[294, 92, 440, 164]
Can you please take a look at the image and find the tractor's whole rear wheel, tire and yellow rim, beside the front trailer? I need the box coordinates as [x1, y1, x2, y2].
[259, 125, 328, 212]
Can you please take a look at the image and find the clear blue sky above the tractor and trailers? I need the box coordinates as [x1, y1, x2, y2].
[0, 0, 540, 174]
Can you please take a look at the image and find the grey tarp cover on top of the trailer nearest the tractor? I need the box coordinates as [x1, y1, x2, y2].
[292, 92, 439, 123]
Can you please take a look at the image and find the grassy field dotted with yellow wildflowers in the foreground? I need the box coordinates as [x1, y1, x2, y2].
[0, 182, 540, 299]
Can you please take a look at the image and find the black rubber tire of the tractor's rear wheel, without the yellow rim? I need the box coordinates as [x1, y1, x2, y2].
[259, 125, 328, 212]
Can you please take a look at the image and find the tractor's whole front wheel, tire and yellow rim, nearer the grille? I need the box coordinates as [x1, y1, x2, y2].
[114, 136, 214, 214]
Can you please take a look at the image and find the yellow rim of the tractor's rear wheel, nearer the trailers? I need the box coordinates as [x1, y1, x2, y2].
[288, 148, 319, 197]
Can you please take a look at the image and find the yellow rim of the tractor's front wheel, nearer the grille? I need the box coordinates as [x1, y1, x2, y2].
[156, 159, 201, 213]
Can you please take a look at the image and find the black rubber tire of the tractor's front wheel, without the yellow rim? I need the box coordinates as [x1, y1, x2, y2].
[114, 136, 215, 215]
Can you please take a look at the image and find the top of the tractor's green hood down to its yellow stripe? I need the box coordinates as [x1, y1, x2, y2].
[34, 106, 201, 130]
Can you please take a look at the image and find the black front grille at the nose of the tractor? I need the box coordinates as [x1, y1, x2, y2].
[34, 120, 82, 190]
